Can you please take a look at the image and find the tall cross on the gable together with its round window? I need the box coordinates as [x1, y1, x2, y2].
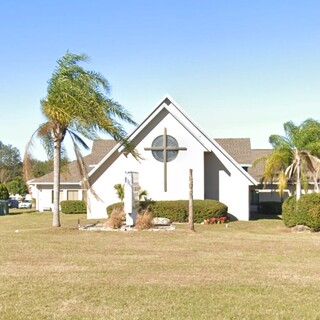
[144, 128, 187, 192]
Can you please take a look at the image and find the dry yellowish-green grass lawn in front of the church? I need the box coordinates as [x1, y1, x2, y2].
[0, 211, 320, 320]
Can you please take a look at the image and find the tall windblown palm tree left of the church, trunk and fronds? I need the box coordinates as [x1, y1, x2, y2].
[25, 52, 135, 227]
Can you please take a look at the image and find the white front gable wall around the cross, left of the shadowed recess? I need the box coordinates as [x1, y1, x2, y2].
[88, 114, 204, 218]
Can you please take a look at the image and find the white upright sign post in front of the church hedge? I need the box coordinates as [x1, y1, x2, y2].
[124, 171, 140, 226]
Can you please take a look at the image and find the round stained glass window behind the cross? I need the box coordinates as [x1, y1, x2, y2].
[152, 135, 179, 162]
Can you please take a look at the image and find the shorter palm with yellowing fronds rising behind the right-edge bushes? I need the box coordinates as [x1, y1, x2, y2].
[265, 119, 320, 199]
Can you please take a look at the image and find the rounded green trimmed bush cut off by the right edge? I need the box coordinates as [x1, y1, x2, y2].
[297, 193, 320, 231]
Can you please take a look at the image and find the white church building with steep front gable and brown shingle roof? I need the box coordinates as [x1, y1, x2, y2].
[29, 96, 257, 220]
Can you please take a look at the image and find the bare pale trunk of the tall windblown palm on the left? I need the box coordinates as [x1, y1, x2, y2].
[52, 139, 61, 227]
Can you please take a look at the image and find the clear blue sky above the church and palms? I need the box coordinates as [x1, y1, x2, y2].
[0, 0, 320, 158]
